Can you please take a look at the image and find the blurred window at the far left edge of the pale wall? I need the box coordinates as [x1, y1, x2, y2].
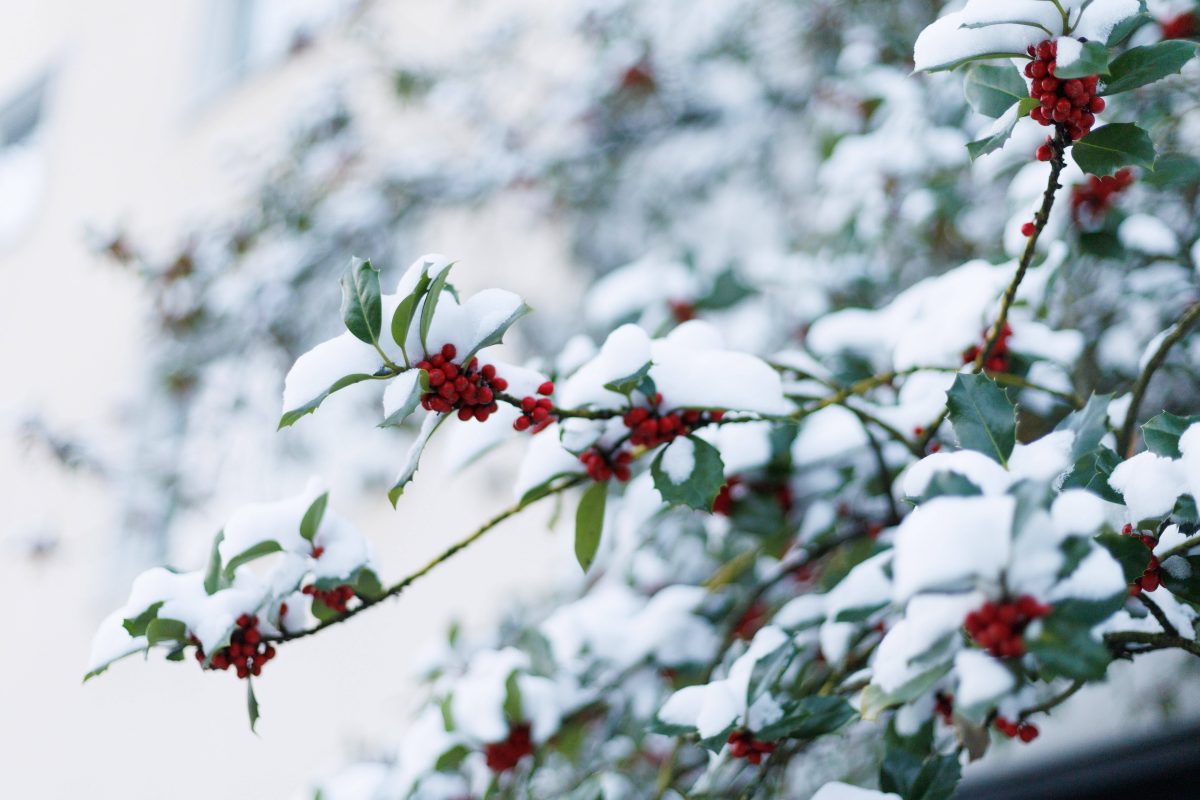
[0, 76, 49, 249]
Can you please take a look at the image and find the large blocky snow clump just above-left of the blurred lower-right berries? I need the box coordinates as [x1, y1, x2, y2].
[893, 495, 1015, 601]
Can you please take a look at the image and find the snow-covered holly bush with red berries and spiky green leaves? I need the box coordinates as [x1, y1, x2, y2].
[89, 0, 1200, 800]
